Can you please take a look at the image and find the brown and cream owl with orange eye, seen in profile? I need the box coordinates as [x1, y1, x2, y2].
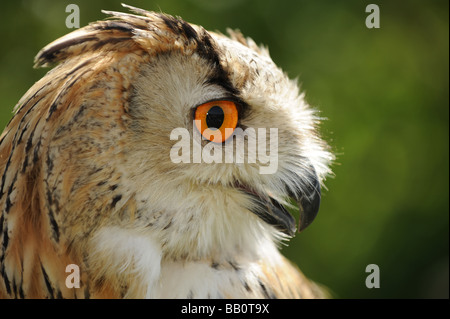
[0, 6, 333, 298]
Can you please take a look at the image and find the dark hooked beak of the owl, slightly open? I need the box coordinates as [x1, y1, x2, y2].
[237, 165, 321, 237]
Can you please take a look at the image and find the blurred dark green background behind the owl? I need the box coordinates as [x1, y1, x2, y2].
[0, 0, 449, 298]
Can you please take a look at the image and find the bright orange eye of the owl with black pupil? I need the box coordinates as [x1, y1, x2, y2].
[194, 101, 238, 143]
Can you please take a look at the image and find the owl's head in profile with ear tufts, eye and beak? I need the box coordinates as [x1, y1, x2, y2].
[5, 6, 333, 268]
